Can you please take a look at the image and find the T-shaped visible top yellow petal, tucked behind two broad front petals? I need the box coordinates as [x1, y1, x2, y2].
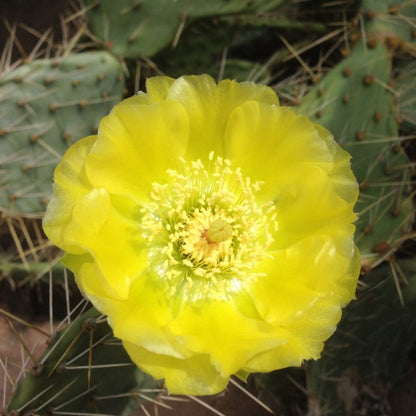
[167, 75, 279, 162]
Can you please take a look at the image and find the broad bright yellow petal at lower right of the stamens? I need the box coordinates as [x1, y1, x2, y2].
[247, 235, 360, 327]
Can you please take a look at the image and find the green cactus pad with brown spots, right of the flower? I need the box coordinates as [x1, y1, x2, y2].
[299, 1, 414, 269]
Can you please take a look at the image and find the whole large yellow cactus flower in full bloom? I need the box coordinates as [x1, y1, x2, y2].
[44, 75, 359, 394]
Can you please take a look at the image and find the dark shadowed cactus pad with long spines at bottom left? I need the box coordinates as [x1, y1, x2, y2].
[6, 308, 161, 416]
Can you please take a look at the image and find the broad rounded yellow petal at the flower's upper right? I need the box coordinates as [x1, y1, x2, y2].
[225, 101, 357, 205]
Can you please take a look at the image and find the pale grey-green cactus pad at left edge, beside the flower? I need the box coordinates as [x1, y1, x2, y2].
[0, 52, 124, 215]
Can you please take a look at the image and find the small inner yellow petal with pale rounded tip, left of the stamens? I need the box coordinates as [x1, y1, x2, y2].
[61, 192, 148, 298]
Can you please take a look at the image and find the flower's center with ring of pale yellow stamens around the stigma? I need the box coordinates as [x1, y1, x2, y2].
[141, 152, 277, 298]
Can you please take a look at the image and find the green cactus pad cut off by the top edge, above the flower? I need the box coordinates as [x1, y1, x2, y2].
[85, 0, 287, 59]
